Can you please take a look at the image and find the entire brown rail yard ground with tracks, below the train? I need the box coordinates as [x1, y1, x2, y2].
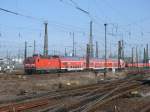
[0, 72, 150, 112]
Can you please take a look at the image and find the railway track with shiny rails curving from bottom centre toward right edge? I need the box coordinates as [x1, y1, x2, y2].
[48, 79, 140, 112]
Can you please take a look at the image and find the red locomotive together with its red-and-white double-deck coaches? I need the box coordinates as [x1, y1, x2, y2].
[24, 55, 125, 74]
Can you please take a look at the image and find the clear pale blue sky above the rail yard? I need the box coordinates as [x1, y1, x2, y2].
[0, 0, 150, 56]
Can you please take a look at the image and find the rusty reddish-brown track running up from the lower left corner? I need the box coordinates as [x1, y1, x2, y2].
[0, 82, 120, 112]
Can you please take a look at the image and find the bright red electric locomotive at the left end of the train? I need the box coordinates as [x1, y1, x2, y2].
[24, 56, 61, 74]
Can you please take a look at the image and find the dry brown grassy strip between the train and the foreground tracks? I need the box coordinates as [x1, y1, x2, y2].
[0, 72, 124, 100]
